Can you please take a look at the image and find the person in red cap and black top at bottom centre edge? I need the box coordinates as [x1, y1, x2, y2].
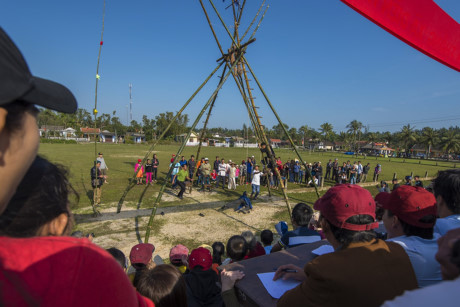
[184, 247, 224, 307]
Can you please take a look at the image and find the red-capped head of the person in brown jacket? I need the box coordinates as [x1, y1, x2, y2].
[314, 184, 378, 249]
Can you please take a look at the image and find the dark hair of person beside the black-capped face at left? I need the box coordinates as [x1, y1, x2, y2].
[0, 156, 78, 238]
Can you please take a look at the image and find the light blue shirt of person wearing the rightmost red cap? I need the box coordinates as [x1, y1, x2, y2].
[387, 233, 442, 288]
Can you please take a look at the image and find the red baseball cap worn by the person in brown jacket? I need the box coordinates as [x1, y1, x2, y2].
[313, 184, 379, 231]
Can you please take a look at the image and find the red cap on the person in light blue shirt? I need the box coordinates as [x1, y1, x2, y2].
[379, 185, 437, 228]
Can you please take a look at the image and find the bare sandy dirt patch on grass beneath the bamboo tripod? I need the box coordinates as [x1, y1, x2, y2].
[76, 192, 286, 259]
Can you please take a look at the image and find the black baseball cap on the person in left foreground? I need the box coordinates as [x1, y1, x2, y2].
[0, 27, 77, 113]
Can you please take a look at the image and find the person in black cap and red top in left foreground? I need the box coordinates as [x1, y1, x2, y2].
[0, 27, 154, 307]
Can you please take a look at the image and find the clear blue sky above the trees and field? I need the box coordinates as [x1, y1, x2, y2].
[0, 0, 460, 131]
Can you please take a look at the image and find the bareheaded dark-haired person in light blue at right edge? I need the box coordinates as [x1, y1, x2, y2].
[433, 169, 460, 236]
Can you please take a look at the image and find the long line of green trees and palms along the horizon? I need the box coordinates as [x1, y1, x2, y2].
[38, 109, 460, 155]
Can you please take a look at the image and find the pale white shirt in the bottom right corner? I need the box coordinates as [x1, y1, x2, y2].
[382, 277, 460, 307]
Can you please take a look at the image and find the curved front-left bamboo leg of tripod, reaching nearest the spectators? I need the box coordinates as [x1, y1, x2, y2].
[144, 54, 242, 243]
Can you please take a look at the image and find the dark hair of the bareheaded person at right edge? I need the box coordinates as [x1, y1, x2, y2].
[433, 169, 460, 214]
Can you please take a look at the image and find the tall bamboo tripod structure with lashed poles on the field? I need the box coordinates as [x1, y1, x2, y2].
[111, 0, 319, 243]
